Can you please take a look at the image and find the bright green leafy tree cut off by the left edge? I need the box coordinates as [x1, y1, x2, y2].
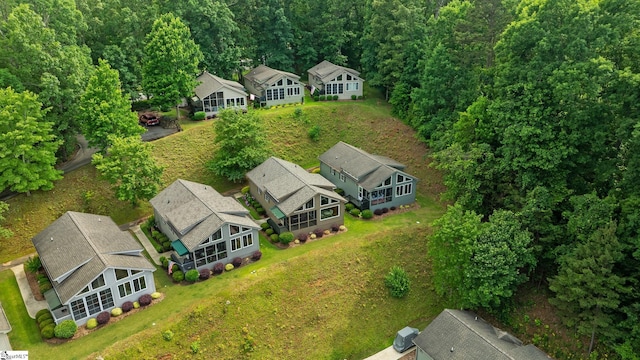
[0, 88, 62, 195]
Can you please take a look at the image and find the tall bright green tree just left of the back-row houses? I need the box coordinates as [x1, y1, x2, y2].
[142, 13, 202, 114]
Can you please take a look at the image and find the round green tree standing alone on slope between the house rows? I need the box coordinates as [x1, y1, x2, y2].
[207, 109, 269, 182]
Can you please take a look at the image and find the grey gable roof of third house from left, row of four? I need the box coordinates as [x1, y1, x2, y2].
[247, 156, 346, 214]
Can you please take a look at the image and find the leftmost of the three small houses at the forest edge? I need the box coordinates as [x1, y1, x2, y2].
[194, 71, 247, 117]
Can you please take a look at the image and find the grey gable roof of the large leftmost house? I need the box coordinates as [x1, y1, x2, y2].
[31, 211, 155, 304]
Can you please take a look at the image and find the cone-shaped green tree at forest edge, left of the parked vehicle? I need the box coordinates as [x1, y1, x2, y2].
[78, 59, 144, 152]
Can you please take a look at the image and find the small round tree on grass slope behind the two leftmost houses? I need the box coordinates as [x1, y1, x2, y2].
[92, 135, 163, 206]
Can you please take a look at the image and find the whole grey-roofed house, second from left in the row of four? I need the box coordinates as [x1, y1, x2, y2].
[150, 179, 260, 271]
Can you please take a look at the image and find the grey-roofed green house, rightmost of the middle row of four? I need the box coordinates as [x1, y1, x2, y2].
[319, 141, 418, 211]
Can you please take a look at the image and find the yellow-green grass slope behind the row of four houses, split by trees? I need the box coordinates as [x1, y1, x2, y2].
[0, 99, 442, 262]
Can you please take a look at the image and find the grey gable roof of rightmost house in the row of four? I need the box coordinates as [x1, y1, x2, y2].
[318, 141, 417, 190]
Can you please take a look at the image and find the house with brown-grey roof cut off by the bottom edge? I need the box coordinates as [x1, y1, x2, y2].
[413, 309, 550, 360]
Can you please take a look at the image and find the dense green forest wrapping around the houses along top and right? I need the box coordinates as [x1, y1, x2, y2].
[0, 0, 640, 359]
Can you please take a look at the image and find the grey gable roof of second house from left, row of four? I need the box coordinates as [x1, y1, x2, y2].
[150, 179, 258, 250]
